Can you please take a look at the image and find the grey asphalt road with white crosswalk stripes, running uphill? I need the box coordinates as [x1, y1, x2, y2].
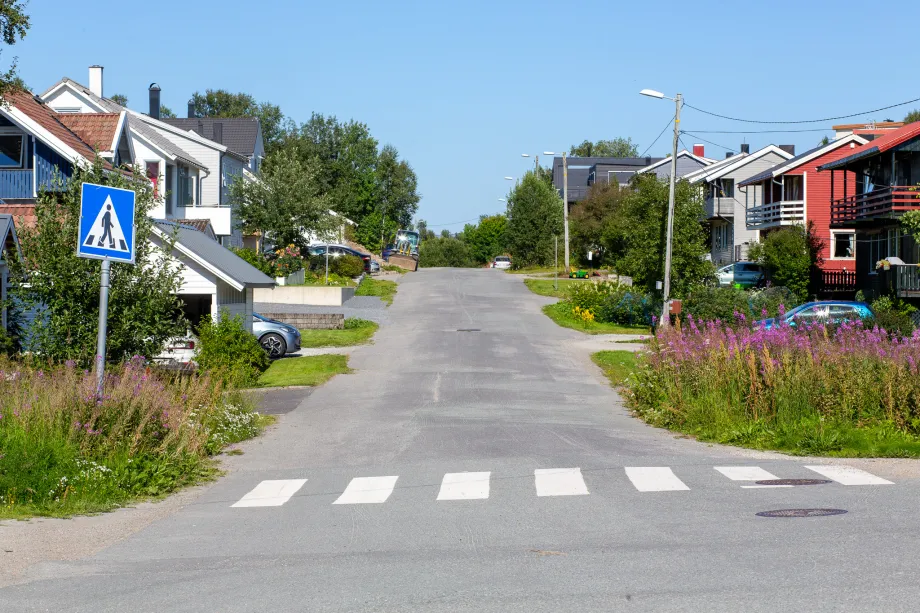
[0, 270, 920, 613]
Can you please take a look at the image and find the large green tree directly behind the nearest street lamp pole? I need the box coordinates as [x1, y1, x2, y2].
[601, 174, 713, 297]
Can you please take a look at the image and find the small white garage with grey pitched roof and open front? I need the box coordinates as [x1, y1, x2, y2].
[151, 220, 275, 332]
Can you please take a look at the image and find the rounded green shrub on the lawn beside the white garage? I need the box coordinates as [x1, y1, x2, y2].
[195, 313, 270, 387]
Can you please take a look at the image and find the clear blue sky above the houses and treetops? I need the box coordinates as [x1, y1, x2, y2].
[12, 0, 920, 231]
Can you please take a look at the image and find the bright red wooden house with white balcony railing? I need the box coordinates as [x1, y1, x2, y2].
[739, 134, 869, 271]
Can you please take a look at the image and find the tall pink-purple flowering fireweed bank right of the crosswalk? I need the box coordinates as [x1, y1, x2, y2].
[624, 320, 920, 457]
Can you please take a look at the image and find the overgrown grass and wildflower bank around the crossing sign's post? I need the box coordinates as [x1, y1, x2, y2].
[0, 358, 273, 519]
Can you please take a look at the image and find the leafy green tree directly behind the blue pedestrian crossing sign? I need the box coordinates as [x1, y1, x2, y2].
[16, 158, 186, 365]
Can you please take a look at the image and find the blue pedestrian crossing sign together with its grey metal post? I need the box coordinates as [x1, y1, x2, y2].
[77, 183, 136, 397]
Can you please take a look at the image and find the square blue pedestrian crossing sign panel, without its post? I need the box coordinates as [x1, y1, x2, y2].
[77, 183, 135, 264]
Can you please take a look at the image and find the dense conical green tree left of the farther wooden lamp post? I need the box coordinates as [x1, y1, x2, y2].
[505, 172, 562, 267]
